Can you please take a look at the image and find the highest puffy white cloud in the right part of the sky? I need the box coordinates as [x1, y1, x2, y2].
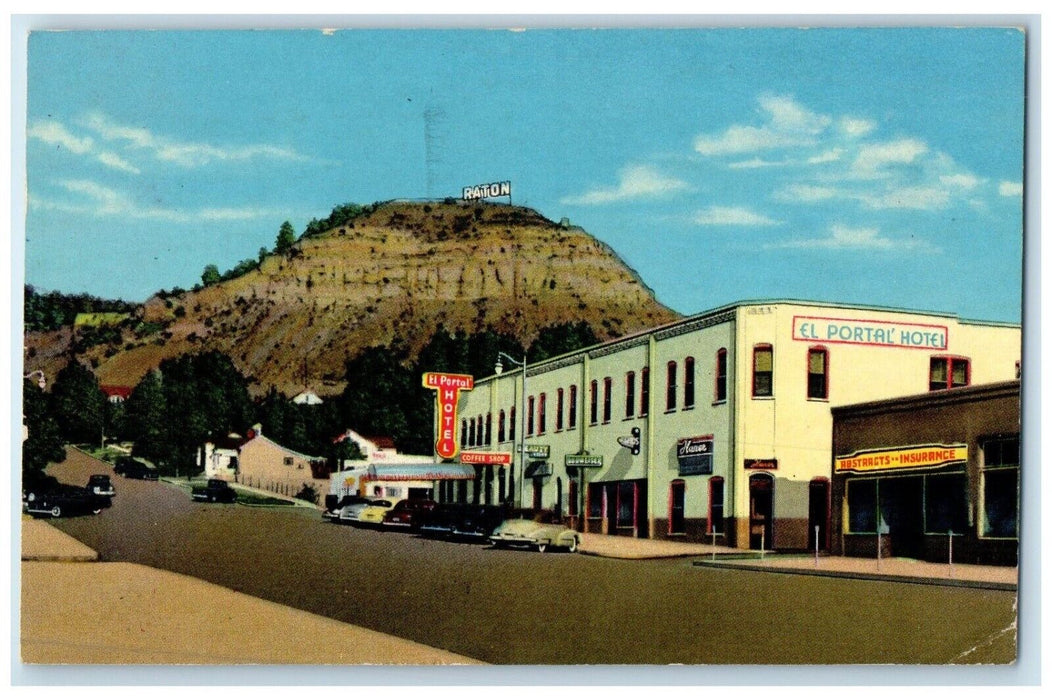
[694, 96, 832, 156]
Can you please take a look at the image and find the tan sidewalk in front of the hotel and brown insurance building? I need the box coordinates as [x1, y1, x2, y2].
[580, 533, 1019, 591]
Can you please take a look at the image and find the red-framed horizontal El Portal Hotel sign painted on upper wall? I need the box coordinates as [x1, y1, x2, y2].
[792, 316, 949, 351]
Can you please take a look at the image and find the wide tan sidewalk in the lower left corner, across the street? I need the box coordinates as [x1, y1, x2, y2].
[21, 517, 481, 665]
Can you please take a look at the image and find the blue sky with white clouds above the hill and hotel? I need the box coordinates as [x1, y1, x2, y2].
[25, 27, 1025, 322]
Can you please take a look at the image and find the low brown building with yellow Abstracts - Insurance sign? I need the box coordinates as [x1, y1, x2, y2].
[829, 380, 1021, 565]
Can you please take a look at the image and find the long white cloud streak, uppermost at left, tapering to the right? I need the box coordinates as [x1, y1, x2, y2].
[84, 112, 308, 167]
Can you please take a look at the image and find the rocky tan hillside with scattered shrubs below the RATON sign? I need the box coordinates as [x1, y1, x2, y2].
[26, 202, 677, 395]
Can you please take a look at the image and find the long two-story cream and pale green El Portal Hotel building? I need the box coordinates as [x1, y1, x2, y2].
[450, 300, 1021, 553]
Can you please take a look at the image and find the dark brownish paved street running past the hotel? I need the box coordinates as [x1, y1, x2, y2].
[37, 449, 1015, 664]
